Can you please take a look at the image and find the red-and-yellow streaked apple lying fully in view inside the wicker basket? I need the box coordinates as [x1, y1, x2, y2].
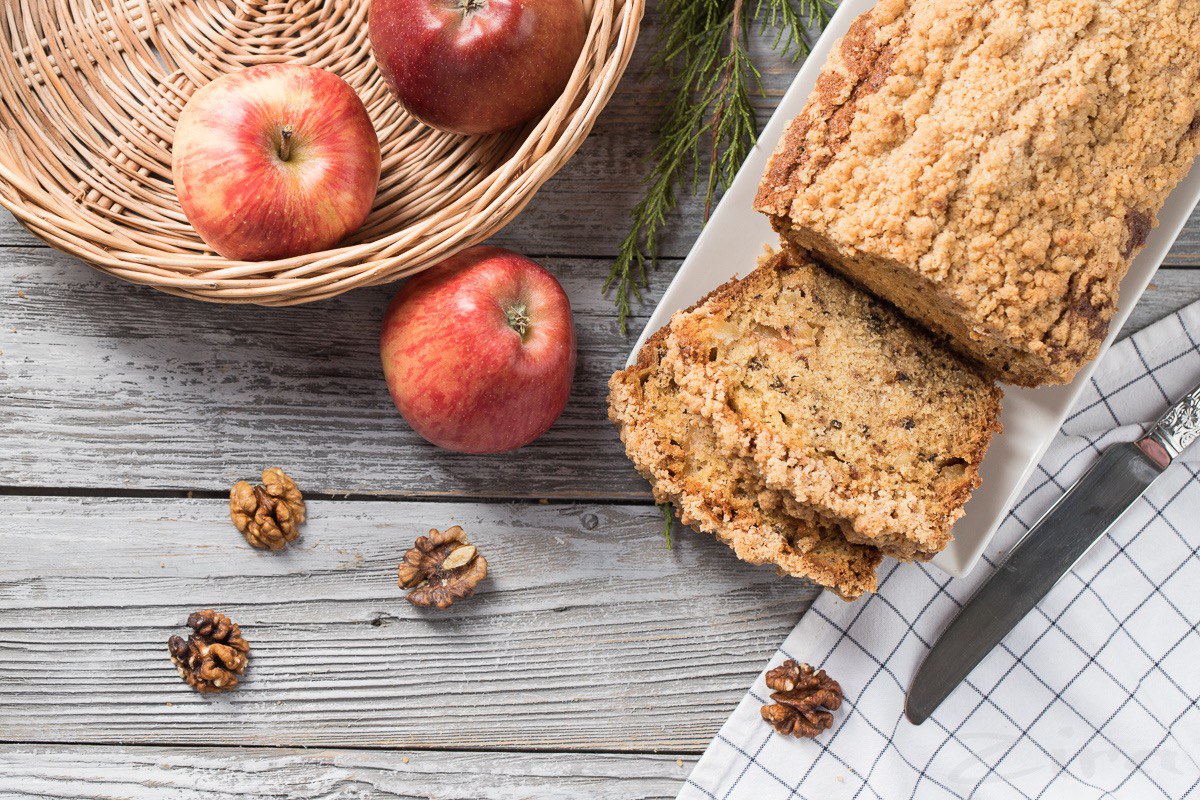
[172, 64, 379, 261]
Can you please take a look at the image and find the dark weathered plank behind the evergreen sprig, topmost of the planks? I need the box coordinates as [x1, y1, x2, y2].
[0, 13, 1200, 262]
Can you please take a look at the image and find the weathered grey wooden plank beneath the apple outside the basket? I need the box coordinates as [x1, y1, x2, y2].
[0, 248, 1200, 501]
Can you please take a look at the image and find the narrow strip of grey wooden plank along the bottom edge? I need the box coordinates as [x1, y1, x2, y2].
[0, 745, 696, 800]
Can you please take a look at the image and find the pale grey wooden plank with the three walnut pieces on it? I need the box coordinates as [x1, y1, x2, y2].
[0, 497, 820, 752]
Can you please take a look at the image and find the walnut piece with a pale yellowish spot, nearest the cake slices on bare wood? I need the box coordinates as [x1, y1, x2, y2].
[398, 525, 487, 608]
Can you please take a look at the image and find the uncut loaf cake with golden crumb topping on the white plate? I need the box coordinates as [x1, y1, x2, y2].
[755, 0, 1200, 386]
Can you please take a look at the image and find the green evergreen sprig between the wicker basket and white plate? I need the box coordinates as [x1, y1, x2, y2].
[604, 0, 829, 333]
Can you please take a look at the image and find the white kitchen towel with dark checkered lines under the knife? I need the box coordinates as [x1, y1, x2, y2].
[679, 303, 1200, 800]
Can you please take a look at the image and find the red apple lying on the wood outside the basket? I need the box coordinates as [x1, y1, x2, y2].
[380, 247, 575, 453]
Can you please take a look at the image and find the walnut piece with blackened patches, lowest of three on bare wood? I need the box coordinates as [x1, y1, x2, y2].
[167, 608, 250, 694]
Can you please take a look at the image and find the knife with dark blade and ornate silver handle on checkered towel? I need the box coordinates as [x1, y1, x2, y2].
[904, 376, 1200, 724]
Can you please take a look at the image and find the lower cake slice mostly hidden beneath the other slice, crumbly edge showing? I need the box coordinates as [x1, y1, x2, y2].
[608, 329, 882, 600]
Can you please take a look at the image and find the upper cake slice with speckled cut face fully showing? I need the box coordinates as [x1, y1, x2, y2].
[660, 251, 1001, 559]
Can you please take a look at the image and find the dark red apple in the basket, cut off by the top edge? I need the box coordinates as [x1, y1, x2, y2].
[367, 0, 587, 133]
